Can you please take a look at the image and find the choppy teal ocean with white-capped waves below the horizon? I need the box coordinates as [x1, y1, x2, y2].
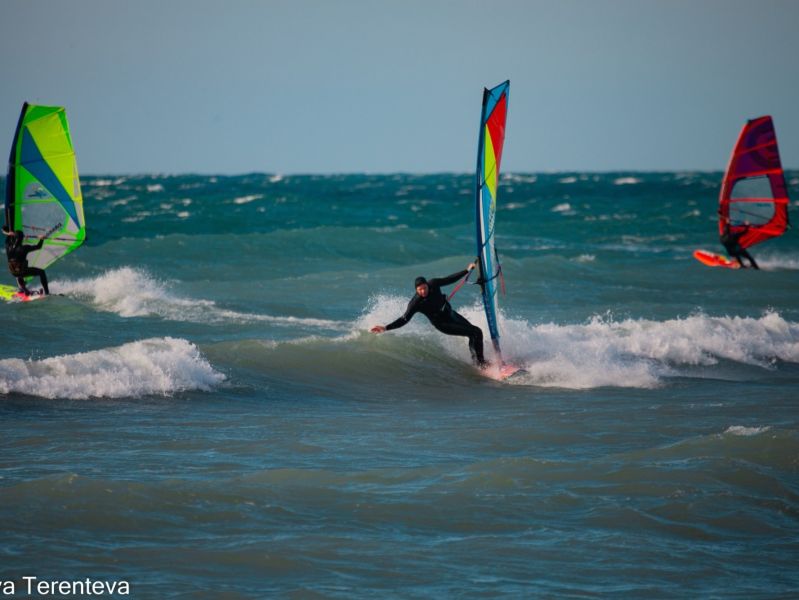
[0, 172, 799, 599]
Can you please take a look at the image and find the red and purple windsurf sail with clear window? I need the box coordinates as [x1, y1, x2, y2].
[719, 116, 788, 248]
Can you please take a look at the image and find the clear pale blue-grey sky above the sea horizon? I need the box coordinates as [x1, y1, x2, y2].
[0, 0, 799, 174]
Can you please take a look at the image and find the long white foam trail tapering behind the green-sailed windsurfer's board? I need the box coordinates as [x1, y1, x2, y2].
[51, 267, 349, 330]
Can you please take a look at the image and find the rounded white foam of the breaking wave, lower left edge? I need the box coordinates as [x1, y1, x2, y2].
[0, 337, 225, 399]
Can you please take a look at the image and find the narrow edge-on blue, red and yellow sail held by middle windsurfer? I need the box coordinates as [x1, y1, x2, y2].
[476, 81, 510, 361]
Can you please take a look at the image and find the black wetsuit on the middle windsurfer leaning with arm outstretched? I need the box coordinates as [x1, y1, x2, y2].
[386, 271, 485, 365]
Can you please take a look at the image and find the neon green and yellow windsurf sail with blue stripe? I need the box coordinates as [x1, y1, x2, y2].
[5, 102, 86, 269]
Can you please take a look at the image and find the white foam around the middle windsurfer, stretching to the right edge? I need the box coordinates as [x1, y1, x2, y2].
[359, 296, 799, 389]
